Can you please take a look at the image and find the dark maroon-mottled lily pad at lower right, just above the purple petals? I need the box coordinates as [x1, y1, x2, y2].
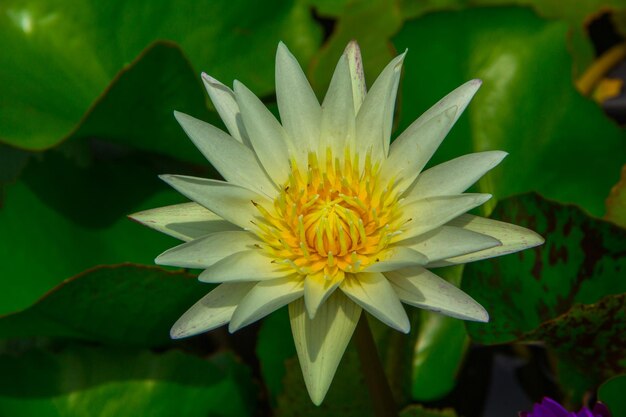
[521, 294, 626, 398]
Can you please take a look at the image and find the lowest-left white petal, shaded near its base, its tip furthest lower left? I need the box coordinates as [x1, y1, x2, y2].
[170, 282, 254, 339]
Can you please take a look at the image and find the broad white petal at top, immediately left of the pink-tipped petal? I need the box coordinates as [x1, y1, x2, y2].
[276, 42, 322, 166]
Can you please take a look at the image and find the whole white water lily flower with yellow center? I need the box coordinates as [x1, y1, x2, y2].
[132, 42, 543, 404]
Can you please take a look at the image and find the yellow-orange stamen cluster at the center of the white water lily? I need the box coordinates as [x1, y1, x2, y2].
[257, 149, 400, 279]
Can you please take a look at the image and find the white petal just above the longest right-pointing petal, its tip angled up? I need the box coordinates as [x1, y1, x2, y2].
[392, 194, 491, 242]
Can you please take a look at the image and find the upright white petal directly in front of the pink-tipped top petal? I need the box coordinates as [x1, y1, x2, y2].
[318, 54, 356, 157]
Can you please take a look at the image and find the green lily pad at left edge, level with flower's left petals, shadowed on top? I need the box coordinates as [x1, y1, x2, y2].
[0, 149, 185, 314]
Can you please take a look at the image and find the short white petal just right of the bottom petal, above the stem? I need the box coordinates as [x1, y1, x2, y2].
[339, 272, 411, 333]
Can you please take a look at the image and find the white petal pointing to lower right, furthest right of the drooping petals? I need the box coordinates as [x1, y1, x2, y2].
[385, 267, 489, 322]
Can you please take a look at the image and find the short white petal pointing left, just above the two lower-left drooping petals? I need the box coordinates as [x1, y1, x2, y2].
[198, 248, 293, 283]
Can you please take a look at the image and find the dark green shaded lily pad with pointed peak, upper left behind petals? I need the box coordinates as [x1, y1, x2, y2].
[69, 41, 221, 165]
